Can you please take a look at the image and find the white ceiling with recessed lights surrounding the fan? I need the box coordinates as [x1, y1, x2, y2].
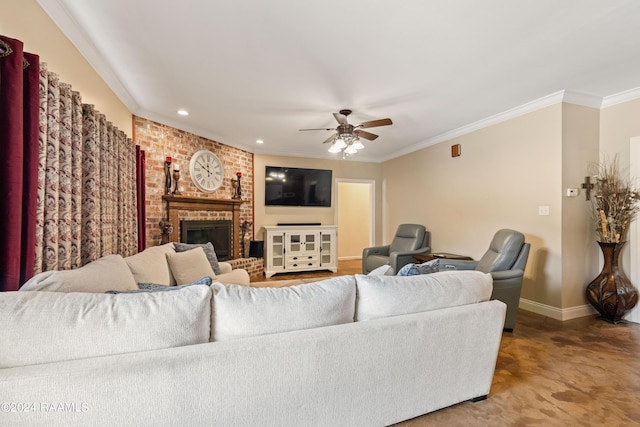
[38, 0, 640, 161]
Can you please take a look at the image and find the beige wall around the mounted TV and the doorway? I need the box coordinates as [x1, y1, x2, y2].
[253, 154, 382, 247]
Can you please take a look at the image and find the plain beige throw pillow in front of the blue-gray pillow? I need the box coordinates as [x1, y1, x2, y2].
[124, 243, 176, 286]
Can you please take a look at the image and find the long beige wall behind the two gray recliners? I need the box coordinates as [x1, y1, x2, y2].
[383, 104, 562, 307]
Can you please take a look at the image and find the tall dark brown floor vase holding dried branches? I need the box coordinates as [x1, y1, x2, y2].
[586, 242, 638, 323]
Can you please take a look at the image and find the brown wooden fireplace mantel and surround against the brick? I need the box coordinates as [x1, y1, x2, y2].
[162, 194, 244, 259]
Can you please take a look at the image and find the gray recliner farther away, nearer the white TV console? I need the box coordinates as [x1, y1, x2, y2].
[362, 224, 431, 274]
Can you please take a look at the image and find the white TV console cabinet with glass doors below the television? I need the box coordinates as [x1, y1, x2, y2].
[264, 225, 338, 277]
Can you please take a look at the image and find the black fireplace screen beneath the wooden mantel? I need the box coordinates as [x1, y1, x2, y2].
[180, 220, 233, 261]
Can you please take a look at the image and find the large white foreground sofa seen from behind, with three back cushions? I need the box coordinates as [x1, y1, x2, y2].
[0, 262, 506, 427]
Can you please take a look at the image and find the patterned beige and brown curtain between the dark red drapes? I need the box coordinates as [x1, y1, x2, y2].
[35, 64, 138, 273]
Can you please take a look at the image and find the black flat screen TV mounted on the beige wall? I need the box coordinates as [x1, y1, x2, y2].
[264, 166, 331, 207]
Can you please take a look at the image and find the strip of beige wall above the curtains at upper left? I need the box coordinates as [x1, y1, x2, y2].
[0, 0, 132, 137]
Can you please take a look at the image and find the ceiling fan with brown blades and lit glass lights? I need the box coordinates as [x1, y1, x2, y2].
[300, 110, 393, 154]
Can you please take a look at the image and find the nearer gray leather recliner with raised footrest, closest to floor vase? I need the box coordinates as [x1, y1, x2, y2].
[440, 229, 531, 332]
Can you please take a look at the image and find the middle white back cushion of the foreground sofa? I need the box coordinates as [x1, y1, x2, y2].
[211, 276, 356, 341]
